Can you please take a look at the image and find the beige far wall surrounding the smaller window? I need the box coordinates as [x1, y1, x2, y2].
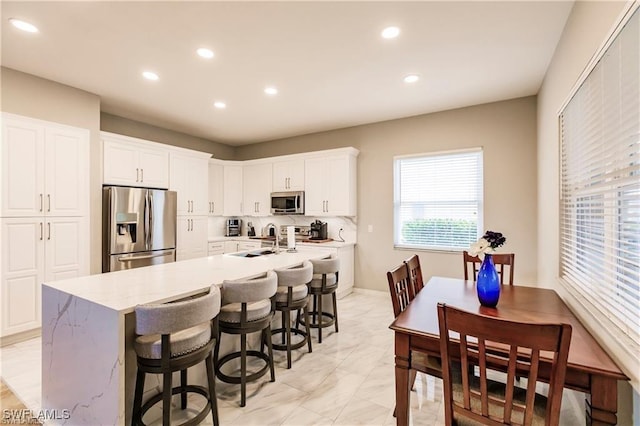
[237, 97, 537, 291]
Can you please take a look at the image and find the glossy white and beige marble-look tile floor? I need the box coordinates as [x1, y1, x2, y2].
[0, 291, 585, 426]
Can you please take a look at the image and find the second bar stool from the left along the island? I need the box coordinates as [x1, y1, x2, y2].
[213, 271, 278, 407]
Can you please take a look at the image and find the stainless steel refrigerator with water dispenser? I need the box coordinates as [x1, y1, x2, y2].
[102, 186, 177, 272]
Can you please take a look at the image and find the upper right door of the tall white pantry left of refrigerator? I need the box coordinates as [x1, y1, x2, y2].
[44, 127, 89, 216]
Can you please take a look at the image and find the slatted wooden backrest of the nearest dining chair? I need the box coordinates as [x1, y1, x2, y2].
[438, 303, 571, 425]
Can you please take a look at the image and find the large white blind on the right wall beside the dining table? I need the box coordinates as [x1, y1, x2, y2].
[560, 9, 640, 357]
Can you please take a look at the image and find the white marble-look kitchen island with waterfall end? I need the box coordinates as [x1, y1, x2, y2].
[42, 250, 327, 425]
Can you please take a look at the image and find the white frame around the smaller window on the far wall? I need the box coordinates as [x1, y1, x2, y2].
[393, 147, 484, 253]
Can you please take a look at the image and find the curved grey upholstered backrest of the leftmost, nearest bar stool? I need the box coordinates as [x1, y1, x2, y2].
[135, 285, 220, 335]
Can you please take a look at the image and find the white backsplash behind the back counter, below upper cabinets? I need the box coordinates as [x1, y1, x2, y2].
[209, 216, 357, 243]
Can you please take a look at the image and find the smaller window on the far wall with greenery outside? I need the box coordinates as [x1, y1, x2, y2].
[394, 149, 482, 250]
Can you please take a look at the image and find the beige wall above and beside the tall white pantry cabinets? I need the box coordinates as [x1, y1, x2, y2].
[0, 67, 102, 273]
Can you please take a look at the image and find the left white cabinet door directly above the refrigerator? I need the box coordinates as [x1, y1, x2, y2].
[103, 139, 142, 186]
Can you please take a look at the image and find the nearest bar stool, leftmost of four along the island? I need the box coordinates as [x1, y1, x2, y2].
[131, 286, 220, 426]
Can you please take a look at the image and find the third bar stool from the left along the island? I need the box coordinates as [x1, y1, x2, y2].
[271, 260, 313, 368]
